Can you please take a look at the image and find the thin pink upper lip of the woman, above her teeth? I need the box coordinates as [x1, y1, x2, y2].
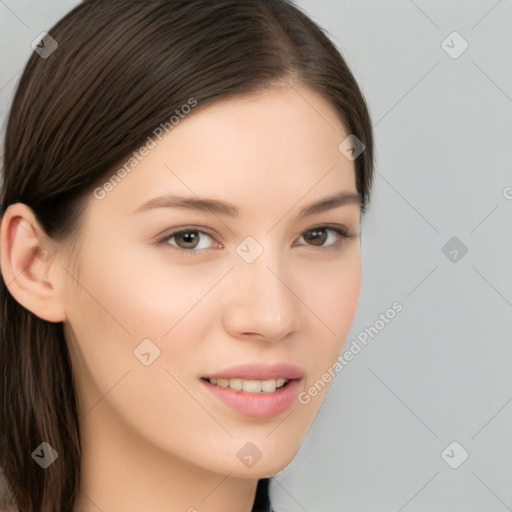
[204, 362, 305, 380]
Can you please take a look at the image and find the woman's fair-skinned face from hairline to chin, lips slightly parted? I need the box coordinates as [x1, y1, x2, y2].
[61, 87, 361, 478]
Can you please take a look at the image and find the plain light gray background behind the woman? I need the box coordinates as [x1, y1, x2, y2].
[0, 0, 512, 512]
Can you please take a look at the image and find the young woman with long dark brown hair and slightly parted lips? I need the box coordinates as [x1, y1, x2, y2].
[0, 0, 373, 512]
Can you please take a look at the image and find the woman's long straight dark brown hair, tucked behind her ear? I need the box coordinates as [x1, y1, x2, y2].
[0, 0, 373, 512]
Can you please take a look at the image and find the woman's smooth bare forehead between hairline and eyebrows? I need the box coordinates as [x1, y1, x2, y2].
[86, 87, 355, 220]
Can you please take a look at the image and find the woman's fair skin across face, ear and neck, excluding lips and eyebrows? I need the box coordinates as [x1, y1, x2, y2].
[1, 86, 361, 512]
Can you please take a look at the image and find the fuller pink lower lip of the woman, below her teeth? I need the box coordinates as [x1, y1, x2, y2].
[202, 380, 300, 418]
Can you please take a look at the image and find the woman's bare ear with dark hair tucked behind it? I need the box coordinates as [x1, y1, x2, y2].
[0, 203, 66, 322]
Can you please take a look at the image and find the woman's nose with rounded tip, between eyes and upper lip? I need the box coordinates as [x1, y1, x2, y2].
[222, 249, 302, 341]
